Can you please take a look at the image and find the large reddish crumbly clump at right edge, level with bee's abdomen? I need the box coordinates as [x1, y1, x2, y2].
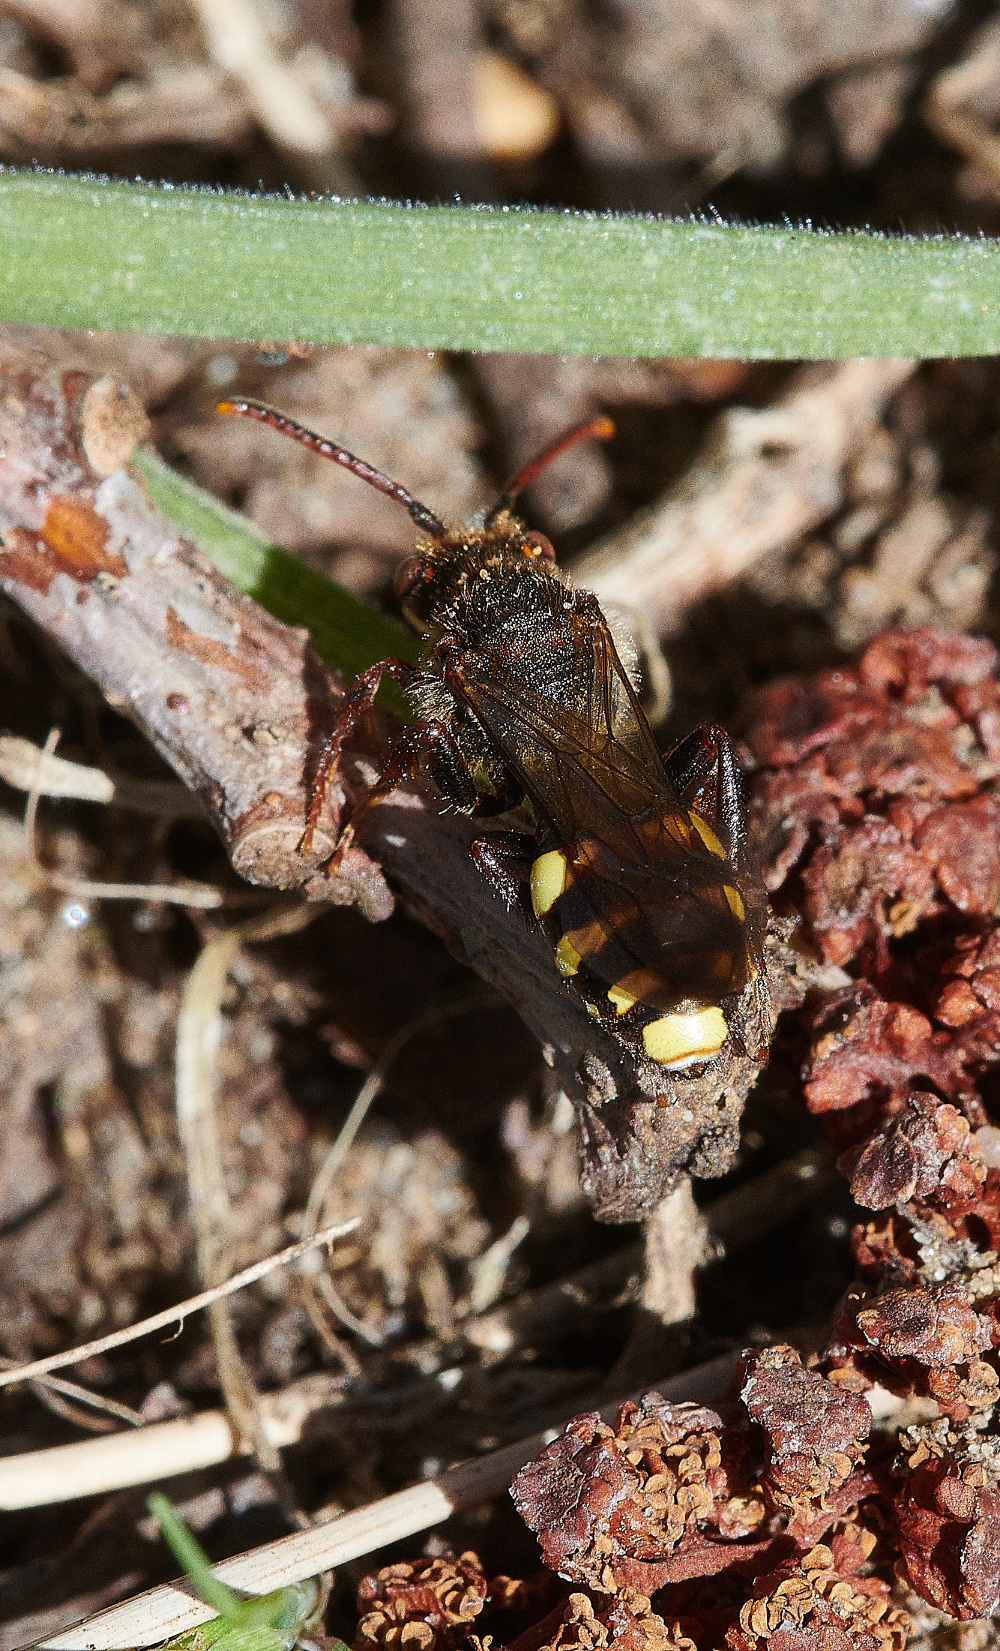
[746, 631, 1000, 964]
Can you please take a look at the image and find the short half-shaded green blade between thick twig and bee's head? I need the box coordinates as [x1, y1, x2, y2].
[134, 449, 421, 717]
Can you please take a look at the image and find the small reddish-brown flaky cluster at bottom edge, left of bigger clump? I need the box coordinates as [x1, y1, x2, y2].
[353, 1552, 495, 1651]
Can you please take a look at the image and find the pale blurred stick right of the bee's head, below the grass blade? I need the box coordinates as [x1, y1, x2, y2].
[574, 360, 917, 634]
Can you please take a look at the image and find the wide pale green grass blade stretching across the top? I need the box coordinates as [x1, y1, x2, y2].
[0, 170, 1000, 360]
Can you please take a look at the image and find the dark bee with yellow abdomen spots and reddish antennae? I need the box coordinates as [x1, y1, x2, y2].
[219, 401, 771, 1071]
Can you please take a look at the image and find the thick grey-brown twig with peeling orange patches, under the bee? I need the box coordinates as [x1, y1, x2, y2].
[0, 348, 788, 1222]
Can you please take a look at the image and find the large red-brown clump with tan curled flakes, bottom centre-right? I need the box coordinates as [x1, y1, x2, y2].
[512, 1373, 906, 1651]
